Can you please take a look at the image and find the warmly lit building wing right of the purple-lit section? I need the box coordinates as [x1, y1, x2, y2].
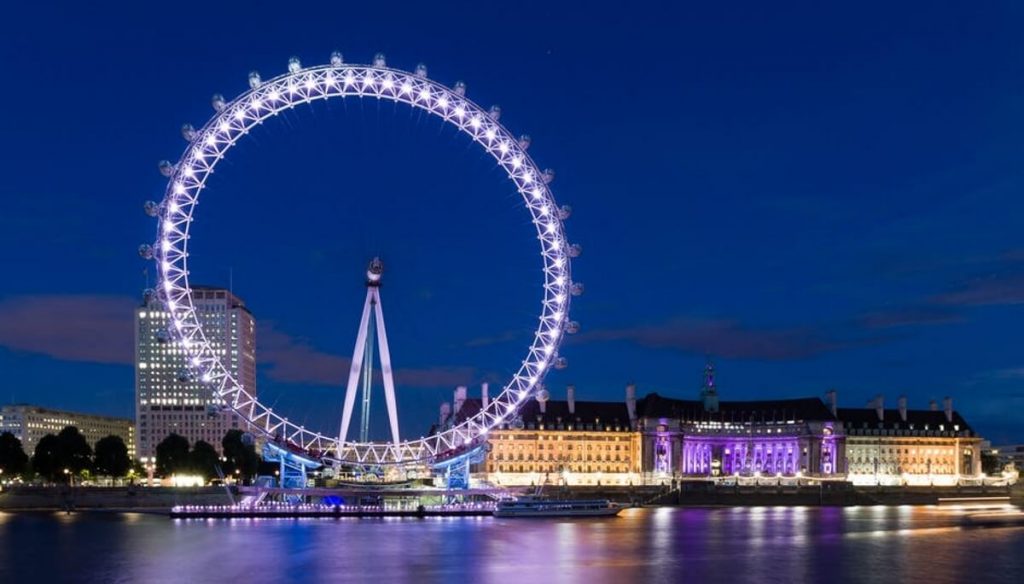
[837, 395, 982, 486]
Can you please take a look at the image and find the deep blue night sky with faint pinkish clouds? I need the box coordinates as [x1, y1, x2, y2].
[0, 1, 1024, 442]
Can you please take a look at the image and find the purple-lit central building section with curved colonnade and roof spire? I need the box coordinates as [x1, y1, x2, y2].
[631, 363, 845, 481]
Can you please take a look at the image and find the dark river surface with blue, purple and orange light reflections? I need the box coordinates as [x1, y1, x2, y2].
[0, 507, 1024, 584]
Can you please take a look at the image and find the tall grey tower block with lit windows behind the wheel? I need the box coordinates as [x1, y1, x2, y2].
[135, 286, 256, 457]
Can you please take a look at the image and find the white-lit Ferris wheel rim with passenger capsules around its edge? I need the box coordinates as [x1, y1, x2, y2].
[152, 57, 578, 464]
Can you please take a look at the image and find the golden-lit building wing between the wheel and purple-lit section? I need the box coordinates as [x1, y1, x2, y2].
[441, 385, 640, 486]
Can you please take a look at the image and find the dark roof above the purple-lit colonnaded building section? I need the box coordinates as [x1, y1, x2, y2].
[637, 393, 836, 422]
